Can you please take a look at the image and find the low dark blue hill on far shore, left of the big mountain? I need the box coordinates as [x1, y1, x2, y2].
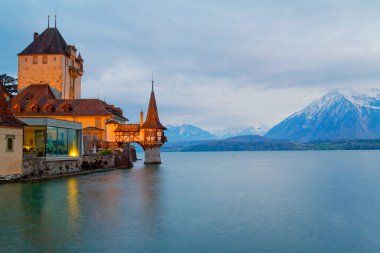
[182, 135, 301, 151]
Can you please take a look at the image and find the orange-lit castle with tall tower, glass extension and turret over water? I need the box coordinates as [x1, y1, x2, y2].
[11, 21, 167, 163]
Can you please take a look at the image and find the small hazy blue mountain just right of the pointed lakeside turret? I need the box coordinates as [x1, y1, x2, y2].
[165, 124, 217, 142]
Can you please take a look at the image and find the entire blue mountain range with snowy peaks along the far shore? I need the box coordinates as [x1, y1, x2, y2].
[164, 89, 380, 151]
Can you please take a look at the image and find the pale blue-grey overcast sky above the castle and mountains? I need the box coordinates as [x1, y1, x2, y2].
[0, 0, 380, 130]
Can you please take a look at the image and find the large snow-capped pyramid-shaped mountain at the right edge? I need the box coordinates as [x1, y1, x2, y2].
[265, 89, 380, 141]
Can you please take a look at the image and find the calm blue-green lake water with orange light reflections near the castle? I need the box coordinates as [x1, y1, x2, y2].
[0, 151, 380, 253]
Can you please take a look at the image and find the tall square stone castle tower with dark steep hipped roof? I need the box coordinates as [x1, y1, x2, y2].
[18, 24, 83, 99]
